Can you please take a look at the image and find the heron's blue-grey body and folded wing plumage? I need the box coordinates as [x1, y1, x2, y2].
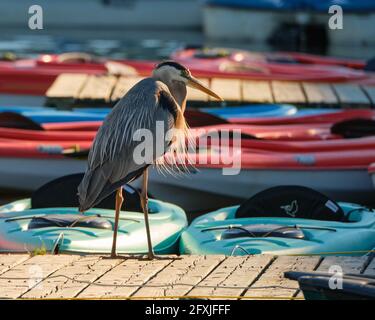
[78, 78, 178, 211]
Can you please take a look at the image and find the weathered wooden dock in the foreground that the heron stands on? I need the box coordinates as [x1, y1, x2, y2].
[0, 254, 375, 300]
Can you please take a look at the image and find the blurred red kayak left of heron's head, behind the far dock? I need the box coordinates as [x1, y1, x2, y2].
[0, 54, 155, 95]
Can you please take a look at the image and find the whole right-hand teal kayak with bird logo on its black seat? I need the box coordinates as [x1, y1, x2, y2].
[180, 187, 375, 256]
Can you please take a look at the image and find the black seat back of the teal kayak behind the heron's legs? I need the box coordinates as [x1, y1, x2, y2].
[31, 173, 142, 212]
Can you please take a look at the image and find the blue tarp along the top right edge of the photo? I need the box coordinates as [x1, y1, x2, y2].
[206, 0, 375, 12]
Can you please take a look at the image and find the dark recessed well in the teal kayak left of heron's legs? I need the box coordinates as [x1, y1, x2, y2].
[28, 214, 112, 230]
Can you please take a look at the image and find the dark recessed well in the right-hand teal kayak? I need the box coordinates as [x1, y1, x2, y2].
[221, 224, 305, 240]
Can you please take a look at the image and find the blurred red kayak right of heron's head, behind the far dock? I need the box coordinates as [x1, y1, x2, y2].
[171, 49, 373, 82]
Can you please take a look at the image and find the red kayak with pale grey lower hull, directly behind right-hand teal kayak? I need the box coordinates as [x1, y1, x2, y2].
[143, 142, 375, 211]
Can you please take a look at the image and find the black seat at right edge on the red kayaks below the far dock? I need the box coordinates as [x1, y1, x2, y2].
[331, 118, 375, 139]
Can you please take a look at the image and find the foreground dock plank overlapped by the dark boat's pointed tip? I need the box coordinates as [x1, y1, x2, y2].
[244, 256, 321, 299]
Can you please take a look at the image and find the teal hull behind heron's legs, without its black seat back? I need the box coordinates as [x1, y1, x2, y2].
[0, 199, 187, 254]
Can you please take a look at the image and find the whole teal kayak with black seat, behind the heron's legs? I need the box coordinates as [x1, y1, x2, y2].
[0, 174, 187, 254]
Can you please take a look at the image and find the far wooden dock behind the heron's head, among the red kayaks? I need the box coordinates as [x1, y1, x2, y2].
[46, 73, 375, 108]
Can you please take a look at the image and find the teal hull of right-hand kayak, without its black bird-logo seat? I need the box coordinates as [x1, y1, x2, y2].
[180, 203, 375, 256]
